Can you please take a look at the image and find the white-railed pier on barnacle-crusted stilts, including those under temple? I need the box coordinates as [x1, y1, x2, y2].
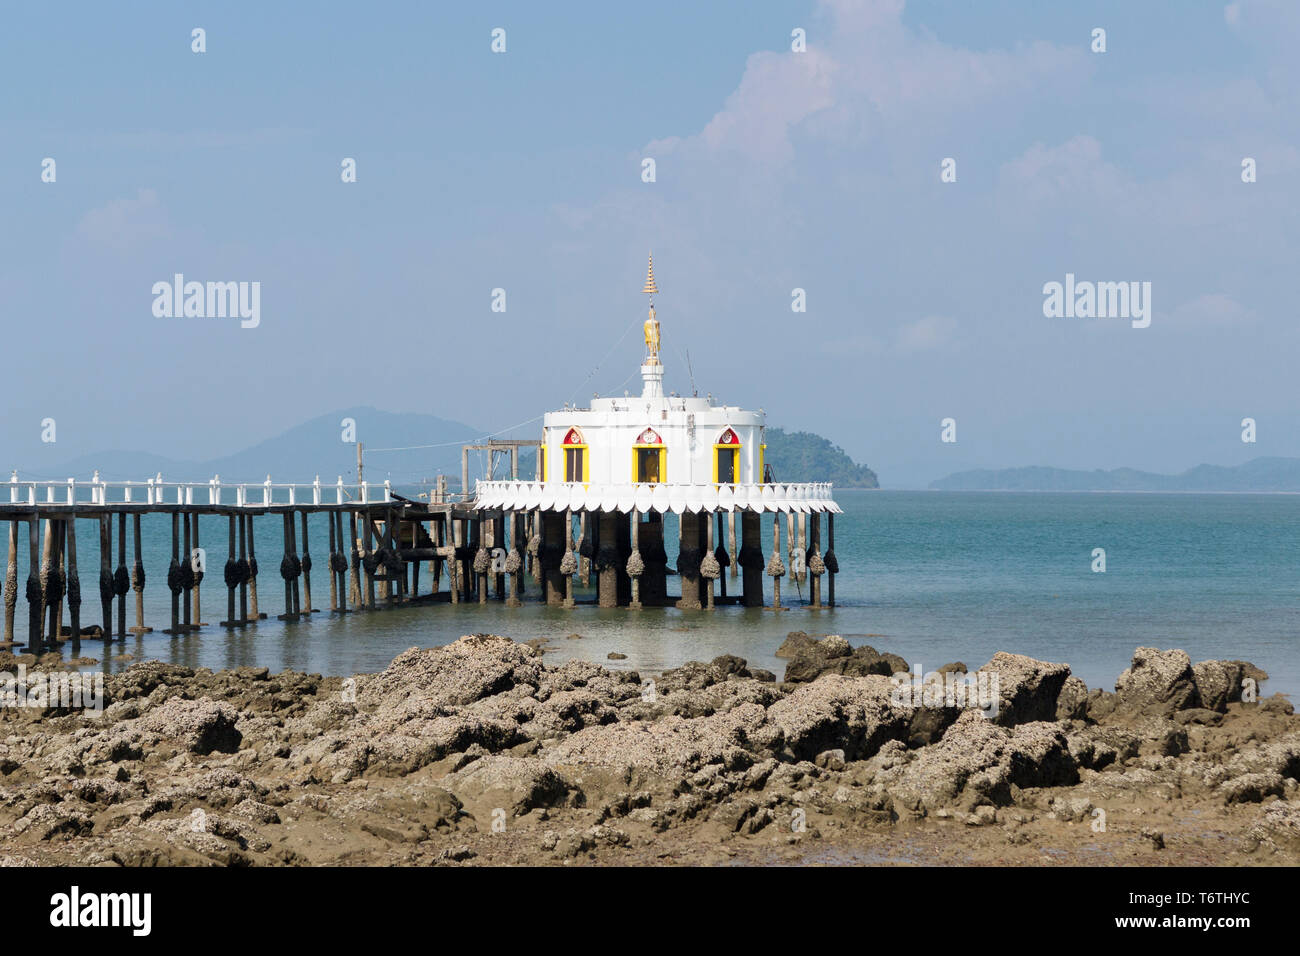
[0, 463, 839, 653]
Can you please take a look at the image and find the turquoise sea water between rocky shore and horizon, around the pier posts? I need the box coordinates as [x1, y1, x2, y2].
[5, 490, 1300, 693]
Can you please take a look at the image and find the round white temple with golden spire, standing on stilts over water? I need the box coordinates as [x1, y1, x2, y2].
[475, 258, 840, 607]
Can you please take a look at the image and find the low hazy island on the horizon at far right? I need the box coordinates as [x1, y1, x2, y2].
[930, 458, 1300, 492]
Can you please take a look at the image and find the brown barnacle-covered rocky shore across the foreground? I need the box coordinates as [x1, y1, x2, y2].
[0, 632, 1300, 865]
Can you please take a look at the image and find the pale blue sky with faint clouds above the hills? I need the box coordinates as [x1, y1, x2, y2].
[0, 0, 1300, 486]
